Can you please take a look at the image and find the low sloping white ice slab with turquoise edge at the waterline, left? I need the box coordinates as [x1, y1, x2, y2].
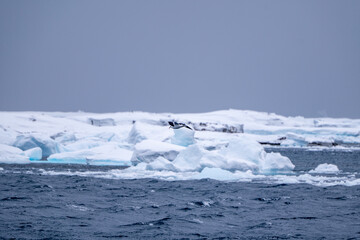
[47, 143, 132, 166]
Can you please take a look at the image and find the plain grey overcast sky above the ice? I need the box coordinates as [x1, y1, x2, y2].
[0, 0, 360, 118]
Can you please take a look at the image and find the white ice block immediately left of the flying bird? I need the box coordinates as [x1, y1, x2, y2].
[128, 122, 171, 144]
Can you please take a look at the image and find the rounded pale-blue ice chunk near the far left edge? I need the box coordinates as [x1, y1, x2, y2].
[13, 134, 59, 158]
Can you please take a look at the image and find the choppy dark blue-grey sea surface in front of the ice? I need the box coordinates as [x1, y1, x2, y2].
[0, 149, 360, 239]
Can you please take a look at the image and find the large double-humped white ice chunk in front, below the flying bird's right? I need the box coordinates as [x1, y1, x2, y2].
[173, 136, 294, 174]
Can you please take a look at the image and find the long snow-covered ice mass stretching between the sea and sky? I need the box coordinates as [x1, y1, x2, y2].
[0, 110, 360, 187]
